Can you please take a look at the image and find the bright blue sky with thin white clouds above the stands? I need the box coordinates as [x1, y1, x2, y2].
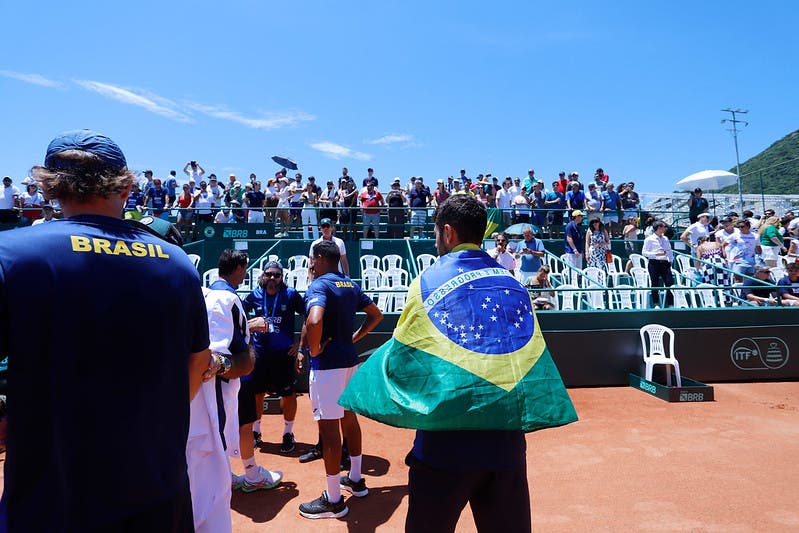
[0, 0, 799, 192]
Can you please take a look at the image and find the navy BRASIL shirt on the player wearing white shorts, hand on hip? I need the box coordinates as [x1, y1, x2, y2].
[305, 272, 372, 370]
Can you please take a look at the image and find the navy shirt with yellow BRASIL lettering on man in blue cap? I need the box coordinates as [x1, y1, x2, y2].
[0, 215, 209, 531]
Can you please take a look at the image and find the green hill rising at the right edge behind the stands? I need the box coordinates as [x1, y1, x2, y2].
[721, 130, 799, 194]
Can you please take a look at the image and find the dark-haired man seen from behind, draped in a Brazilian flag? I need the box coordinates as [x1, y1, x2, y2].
[339, 195, 577, 532]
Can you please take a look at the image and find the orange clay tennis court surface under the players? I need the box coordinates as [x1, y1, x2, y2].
[0, 383, 799, 532]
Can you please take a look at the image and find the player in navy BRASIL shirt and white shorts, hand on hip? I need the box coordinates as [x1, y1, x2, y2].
[297, 241, 383, 518]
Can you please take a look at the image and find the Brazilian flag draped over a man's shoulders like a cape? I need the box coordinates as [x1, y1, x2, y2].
[339, 245, 577, 431]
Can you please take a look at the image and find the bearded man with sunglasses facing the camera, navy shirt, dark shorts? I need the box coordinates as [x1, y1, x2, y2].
[239, 261, 305, 453]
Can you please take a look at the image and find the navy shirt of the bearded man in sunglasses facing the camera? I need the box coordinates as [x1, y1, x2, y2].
[244, 287, 305, 357]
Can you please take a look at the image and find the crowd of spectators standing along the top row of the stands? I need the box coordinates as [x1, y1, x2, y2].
[0, 165, 640, 240]
